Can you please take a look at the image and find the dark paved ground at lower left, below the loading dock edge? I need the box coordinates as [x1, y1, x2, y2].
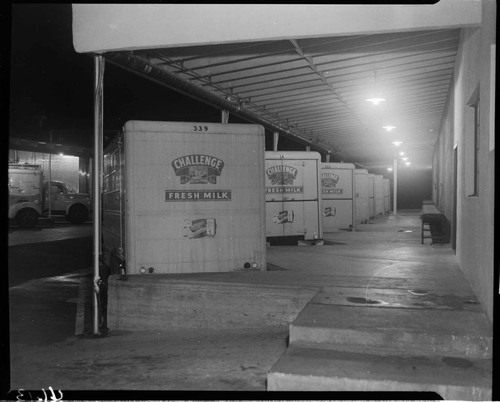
[3, 224, 288, 400]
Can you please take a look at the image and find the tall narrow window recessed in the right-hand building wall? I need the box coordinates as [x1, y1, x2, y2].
[465, 87, 480, 197]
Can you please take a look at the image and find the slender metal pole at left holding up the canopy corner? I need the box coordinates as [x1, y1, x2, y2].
[92, 55, 104, 335]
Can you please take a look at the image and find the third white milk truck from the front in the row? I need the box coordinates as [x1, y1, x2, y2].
[321, 163, 356, 232]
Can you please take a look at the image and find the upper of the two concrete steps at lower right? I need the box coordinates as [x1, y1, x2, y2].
[290, 302, 493, 358]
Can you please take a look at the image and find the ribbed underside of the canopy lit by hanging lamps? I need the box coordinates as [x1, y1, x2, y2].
[105, 29, 460, 168]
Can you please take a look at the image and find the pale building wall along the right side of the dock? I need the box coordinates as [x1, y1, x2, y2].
[433, 0, 496, 320]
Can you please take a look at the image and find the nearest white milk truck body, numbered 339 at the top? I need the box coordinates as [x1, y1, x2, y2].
[103, 121, 266, 275]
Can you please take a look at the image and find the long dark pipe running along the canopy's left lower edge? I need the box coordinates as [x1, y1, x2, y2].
[104, 52, 328, 152]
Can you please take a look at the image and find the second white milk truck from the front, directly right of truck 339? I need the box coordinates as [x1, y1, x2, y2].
[265, 151, 323, 241]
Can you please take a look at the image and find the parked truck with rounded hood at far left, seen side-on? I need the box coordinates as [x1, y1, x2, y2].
[9, 163, 92, 227]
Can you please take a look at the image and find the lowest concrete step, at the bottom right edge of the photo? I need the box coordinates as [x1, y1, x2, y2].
[267, 344, 492, 401]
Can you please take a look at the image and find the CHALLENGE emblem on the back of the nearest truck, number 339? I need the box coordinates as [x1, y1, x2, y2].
[172, 154, 224, 184]
